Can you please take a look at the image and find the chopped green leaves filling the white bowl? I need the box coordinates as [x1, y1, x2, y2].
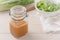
[37, 1, 59, 12]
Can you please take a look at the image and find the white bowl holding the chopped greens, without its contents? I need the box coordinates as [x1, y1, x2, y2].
[35, 0, 60, 17]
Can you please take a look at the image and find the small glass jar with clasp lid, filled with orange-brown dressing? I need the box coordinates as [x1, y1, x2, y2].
[9, 5, 28, 38]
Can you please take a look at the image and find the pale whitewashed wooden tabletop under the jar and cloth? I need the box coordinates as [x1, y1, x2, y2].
[0, 10, 60, 40]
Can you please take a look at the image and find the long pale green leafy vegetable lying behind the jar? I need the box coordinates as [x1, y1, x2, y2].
[0, 0, 34, 11]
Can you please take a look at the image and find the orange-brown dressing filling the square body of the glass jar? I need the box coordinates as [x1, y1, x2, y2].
[10, 21, 28, 38]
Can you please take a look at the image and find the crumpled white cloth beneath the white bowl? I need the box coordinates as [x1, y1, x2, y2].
[40, 16, 60, 32]
